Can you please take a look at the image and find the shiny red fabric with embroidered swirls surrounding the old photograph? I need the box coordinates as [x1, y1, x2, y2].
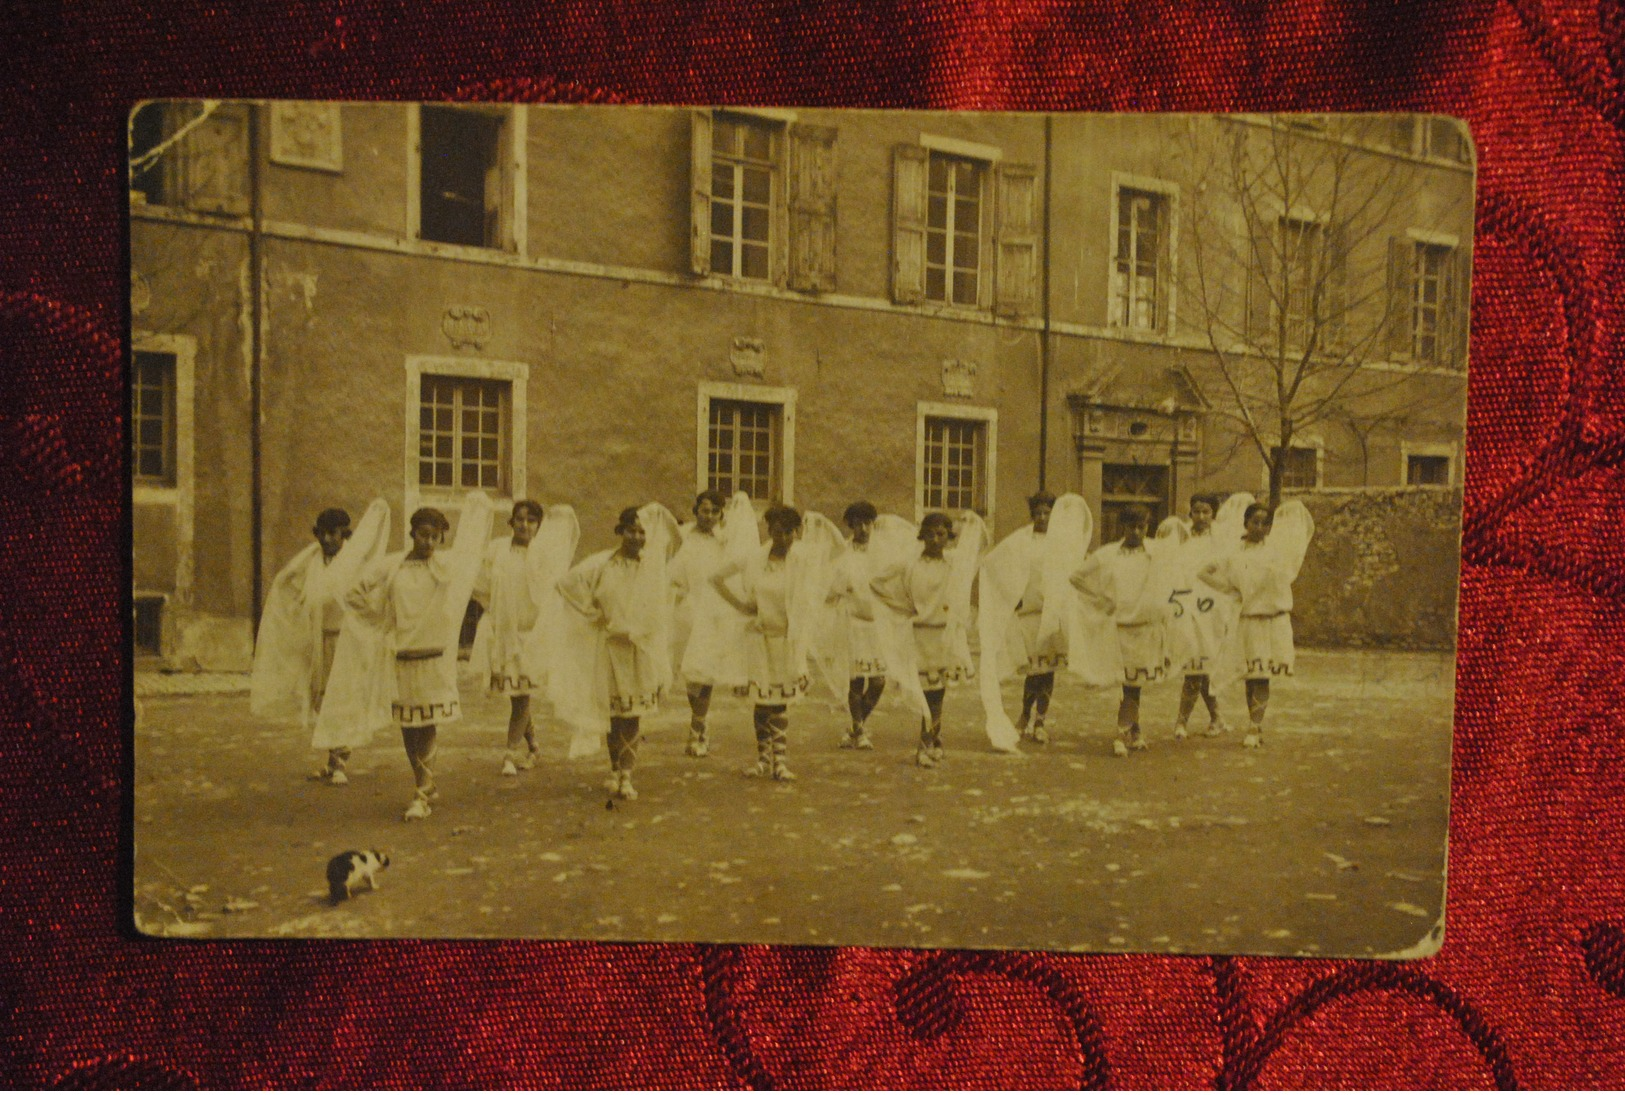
[0, 0, 1625, 1087]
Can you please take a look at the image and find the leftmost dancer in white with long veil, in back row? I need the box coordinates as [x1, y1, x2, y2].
[249, 499, 390, 786]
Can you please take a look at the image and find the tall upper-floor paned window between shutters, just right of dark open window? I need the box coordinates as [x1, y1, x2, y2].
[710, 114, 783, 281]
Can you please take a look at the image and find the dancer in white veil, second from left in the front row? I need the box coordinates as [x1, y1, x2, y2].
[548, 502, 678, 799]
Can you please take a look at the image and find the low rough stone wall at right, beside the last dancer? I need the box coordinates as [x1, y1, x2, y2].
[1289, 487, 1461, 650]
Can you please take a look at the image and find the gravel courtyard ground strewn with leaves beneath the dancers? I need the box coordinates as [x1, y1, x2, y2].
[133, 650, 1454, 957]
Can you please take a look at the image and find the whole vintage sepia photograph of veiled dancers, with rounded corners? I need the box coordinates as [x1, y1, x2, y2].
[128, 101, 1474, 960]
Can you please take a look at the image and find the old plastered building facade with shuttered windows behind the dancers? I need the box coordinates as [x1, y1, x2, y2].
[130, 102, 1472, 668]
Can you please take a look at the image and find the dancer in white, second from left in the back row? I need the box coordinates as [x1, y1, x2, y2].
[468, 499, 582, 775]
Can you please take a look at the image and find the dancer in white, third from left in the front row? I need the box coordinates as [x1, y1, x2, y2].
[712, 504, 843, 781]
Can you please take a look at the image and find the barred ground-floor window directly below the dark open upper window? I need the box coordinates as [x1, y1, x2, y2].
[418, 374, 512, 494]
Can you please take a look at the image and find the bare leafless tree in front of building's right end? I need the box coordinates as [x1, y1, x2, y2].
[1180, 117, 1464, 505]
